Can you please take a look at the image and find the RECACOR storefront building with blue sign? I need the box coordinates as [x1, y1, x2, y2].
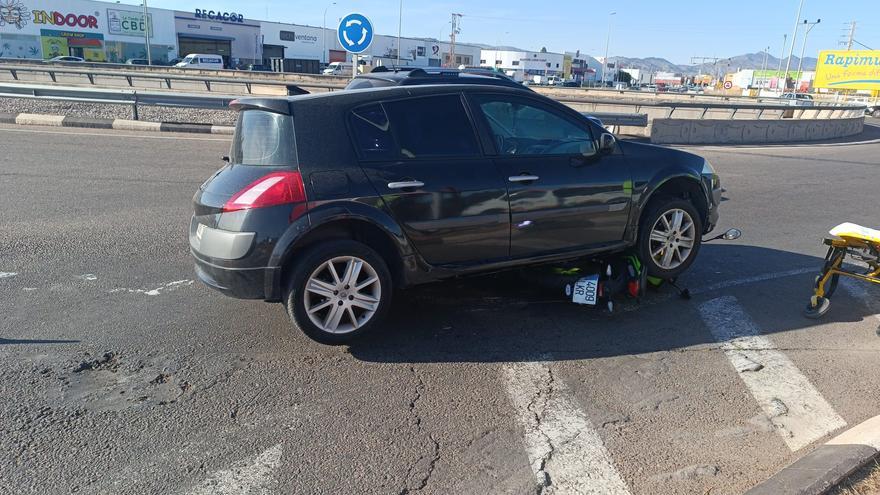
[174, 9, 263, 68]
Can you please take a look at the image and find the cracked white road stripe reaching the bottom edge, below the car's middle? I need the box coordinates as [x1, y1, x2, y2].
[503, 362, 630, 494]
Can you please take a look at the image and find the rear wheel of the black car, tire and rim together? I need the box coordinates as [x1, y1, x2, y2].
[284, 240, 393, 345]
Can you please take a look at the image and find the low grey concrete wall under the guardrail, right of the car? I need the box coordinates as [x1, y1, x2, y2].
[650, 117, 865, 144]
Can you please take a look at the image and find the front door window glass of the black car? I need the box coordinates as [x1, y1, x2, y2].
[477, 96, 596, 156]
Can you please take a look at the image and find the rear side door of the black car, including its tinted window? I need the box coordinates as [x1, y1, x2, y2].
[349, 93, 510, 265]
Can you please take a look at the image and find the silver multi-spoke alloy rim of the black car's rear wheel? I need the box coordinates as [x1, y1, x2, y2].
[303, 256, 382, 334]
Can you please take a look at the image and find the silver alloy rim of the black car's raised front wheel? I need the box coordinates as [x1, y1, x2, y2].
[649, 208, 696, 270]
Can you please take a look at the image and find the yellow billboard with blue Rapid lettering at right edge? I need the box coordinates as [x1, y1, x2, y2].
[813, 50, 880, 91]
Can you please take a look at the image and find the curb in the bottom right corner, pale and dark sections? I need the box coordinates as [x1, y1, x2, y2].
[746, 416, 880, 495]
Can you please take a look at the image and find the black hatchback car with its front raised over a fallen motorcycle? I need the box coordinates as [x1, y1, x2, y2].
[189, 84, 721, 343]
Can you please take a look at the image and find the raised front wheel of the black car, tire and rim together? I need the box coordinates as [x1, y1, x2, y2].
[638, 197, 703, 280]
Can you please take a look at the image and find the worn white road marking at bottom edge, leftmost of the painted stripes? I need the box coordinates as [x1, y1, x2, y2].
[190, 443, 282, 495]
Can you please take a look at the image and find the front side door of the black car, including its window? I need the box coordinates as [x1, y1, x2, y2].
[471, 94, 632, 257]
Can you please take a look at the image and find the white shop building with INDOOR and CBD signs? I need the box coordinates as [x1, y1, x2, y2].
[0, 0, 177, 63]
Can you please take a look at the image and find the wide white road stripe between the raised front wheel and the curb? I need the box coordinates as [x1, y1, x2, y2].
[699, 296, 846, 451]
